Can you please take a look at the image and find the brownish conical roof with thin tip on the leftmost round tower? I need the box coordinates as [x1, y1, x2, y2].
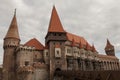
[4, 9, 20, 39]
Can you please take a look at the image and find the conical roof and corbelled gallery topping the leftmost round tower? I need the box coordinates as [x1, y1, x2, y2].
[3, 10, 20, 49]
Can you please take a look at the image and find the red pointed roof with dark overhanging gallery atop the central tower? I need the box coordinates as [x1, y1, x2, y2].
[45, 6, 66, 43]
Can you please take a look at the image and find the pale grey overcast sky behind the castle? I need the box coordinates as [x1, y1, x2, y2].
[0, 0, 120, 64]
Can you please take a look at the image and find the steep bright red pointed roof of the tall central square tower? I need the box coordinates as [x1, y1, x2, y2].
[48, 6, 65, 32]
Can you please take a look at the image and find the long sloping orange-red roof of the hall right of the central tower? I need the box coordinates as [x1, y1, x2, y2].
[66, 32, 87, 45]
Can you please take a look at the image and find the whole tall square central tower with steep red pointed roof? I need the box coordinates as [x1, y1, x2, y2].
[45, 6, 66, 80]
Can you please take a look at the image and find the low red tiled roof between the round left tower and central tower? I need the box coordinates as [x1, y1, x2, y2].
[24, 38, 44, 50]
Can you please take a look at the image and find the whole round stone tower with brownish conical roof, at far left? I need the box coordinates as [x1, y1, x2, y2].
[3, 10, 20, 80]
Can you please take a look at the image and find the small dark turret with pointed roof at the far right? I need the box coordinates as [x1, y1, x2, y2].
[105, 39, 115, 56]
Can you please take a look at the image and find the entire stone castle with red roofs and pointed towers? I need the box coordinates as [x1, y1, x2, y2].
[3, 6, 120, 80]
